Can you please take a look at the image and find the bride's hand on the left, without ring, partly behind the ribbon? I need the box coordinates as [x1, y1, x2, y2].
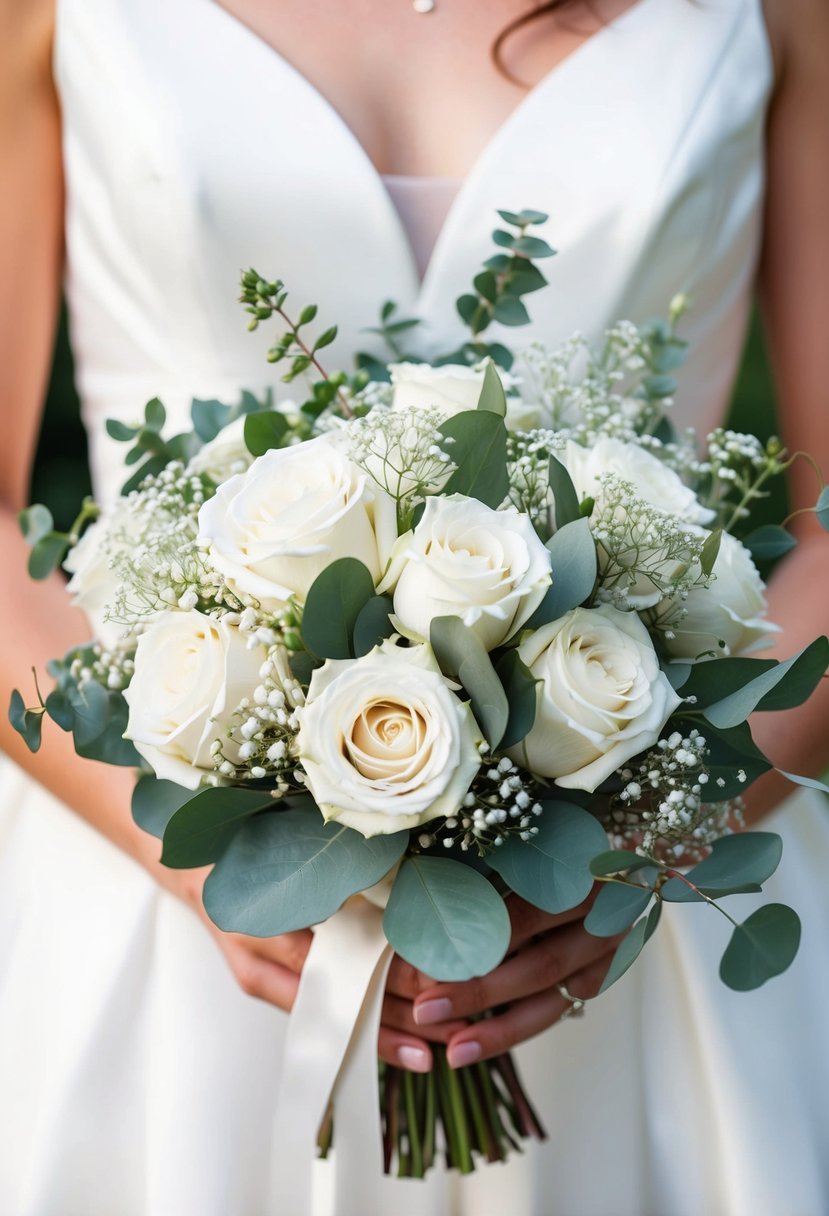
[164, 866, 467, 1073]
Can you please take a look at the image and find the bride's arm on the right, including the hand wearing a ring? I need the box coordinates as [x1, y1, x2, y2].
[415, 0, 829, 1064]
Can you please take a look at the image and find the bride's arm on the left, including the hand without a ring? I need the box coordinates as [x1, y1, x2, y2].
[0, 7, 444, 1070]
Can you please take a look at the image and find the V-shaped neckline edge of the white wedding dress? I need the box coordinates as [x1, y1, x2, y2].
[205, 0, 655, 299]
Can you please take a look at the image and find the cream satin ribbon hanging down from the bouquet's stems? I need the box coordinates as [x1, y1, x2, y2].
[272, 884, 393, 1216]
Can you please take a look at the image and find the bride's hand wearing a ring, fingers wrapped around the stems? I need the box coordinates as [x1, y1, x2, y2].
[405, 896, 621, 1068]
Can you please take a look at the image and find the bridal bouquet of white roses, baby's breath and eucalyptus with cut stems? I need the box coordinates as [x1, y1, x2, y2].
[11, 212, 829, 1175]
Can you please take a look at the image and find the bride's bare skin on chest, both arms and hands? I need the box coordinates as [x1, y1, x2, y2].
[0, 0, 829, 1070]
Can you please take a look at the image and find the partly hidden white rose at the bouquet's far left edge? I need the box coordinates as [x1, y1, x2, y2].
[63, 499, 135, 649]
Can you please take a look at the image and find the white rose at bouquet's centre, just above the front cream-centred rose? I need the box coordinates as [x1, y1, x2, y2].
[379, 495, 552, 651]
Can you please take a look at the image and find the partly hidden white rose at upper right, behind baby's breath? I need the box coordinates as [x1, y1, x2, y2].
[559, 435, 714, 524]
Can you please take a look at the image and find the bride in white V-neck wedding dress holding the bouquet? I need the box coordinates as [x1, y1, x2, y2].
[0, 0, 829, 1216]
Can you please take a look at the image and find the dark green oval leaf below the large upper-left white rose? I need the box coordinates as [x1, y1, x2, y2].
[303, 557, 374, 659]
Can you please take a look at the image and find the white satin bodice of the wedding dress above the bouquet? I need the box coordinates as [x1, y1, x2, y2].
[55, 0, 772, 503]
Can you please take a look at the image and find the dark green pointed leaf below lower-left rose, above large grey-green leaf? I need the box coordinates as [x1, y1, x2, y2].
[162, 786, 273, 869]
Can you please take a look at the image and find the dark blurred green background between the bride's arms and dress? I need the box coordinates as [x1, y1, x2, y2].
[30, 304, 785, 530]
